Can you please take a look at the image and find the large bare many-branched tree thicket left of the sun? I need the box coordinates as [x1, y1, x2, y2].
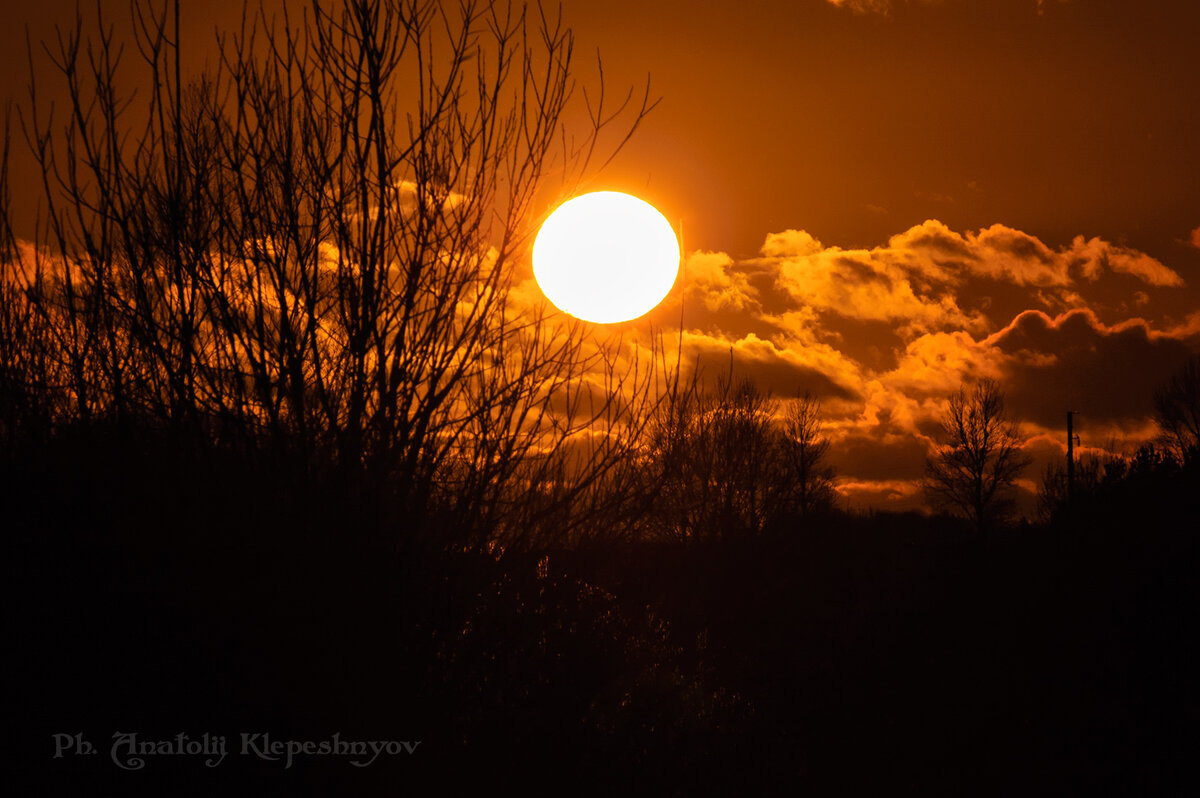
[0, 0, 667, 547]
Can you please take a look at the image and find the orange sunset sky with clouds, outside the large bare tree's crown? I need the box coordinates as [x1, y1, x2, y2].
[0, 0, 1200, 509]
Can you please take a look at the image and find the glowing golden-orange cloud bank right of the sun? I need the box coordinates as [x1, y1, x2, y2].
[656, 220, 1200, 509]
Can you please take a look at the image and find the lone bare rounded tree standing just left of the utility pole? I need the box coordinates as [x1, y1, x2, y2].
[923, 379, 1030, 530]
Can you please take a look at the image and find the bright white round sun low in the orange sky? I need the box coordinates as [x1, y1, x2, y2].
[533, 191, 679, 324]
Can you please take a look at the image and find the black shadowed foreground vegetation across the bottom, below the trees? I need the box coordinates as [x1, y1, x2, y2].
[0, 422, 1200, 794]
